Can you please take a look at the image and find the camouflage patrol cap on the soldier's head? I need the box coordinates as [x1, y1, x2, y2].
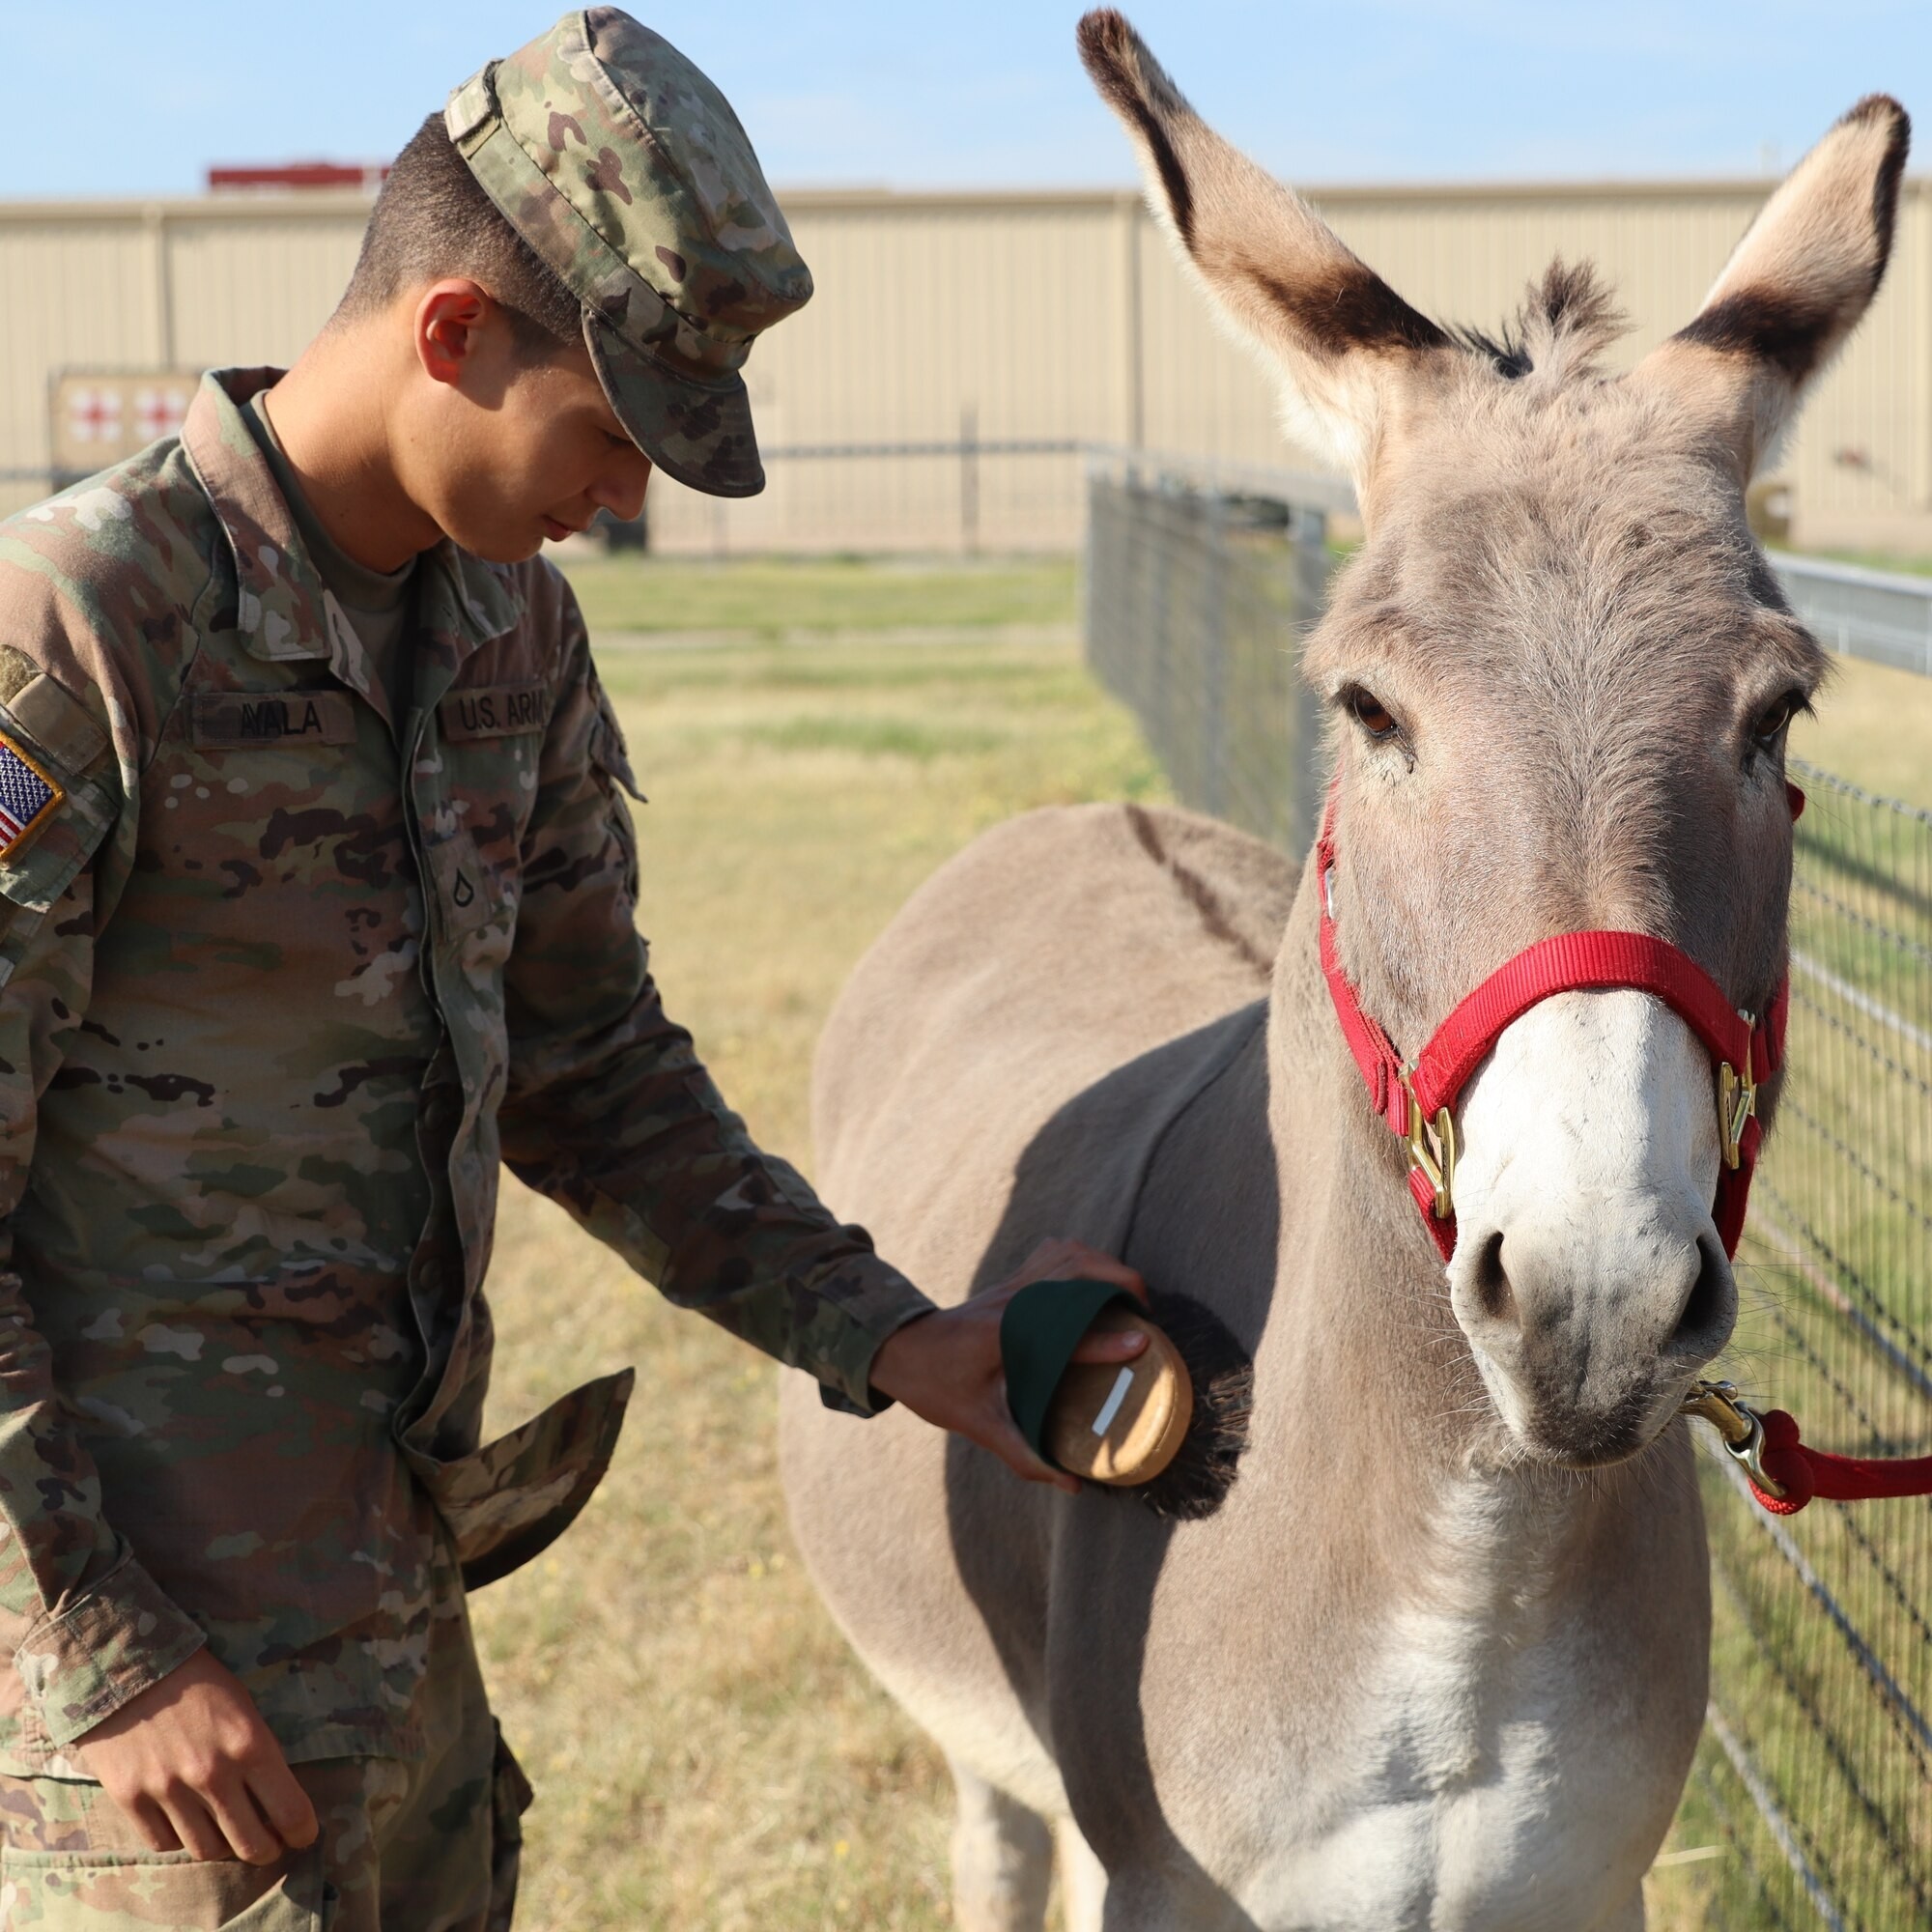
[442, 6, 811, 497]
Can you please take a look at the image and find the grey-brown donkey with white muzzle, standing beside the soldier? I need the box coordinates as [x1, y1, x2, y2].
[782, 12, 1909, 1932]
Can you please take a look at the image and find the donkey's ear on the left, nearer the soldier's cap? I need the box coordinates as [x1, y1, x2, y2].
[1080, 8, 1459, 487]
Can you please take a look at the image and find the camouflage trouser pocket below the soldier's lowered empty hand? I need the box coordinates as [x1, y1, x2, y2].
[0, 1845, 325, 1932]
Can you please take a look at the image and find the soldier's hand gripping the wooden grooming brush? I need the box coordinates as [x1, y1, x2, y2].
[871, 1240, 1148, 1493]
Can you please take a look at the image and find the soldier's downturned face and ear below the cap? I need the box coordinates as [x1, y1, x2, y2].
[396, 284, 651, 564]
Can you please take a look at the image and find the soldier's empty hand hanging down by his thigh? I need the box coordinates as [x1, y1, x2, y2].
[79, 1650, 317, 1864]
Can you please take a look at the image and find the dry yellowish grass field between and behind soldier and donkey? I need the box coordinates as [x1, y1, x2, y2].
[475, 560, 1932, 1932]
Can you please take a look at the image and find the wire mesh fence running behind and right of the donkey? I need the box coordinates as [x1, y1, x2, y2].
[1084, 454, 1932, 1932]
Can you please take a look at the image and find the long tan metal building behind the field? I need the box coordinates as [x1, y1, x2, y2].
[0, 182, 1932, 553]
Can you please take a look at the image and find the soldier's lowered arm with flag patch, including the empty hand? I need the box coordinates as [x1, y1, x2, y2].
[0, 514, 315, 1862]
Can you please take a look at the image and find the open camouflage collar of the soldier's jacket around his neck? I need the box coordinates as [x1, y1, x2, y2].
[182, 369, 520, 715]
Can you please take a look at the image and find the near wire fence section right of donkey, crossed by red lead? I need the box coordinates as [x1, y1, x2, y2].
[1690, 759, 1932, 1932]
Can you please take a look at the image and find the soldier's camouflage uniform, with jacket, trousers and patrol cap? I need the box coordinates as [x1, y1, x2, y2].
[0, 10, 927, 1926]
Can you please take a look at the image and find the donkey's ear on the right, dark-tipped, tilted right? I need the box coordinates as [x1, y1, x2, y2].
[1640, 95, 1913, 481]
